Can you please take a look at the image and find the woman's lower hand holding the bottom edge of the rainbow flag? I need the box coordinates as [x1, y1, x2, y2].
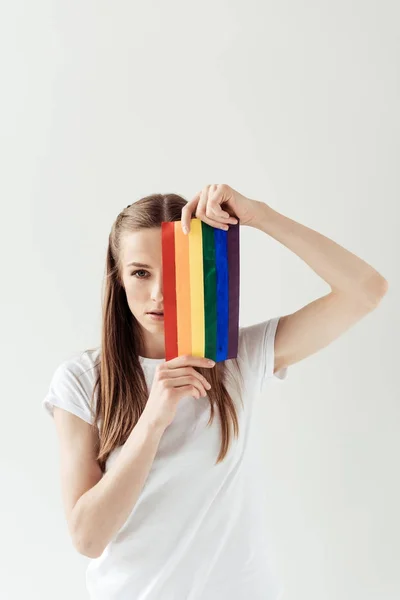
[144, 354, 215, 429]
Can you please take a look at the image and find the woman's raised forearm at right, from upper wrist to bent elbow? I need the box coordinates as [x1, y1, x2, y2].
[251, 200, 387, 303]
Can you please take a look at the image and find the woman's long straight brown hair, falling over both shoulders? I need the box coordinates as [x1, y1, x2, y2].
[91, 194, 243, 470]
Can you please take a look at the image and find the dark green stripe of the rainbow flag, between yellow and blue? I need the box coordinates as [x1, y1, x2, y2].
[201, 221, 217, 360]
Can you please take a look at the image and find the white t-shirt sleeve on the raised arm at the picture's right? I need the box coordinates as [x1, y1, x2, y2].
[239, 317, 288, 386]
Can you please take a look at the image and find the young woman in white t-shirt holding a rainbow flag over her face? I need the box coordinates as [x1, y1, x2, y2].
[43, 184, 387, 600]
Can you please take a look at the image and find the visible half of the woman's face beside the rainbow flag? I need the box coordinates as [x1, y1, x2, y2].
[121, 227, 164, 352]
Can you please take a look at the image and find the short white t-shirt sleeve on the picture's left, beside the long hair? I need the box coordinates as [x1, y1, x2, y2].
[42, 361, 94, 424]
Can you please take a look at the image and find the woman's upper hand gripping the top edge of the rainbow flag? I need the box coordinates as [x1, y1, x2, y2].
[181, 183, 257, 233]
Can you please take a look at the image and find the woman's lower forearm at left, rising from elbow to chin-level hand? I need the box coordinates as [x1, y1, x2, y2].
[71, 410, 165, 558]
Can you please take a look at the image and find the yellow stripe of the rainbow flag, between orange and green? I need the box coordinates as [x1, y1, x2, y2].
[189, 218, 205, 356]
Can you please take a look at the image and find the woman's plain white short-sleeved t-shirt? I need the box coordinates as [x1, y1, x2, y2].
[43, 317, 287, 600]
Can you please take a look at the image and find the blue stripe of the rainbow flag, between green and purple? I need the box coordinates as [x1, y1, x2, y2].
[214, 228, 229, 362]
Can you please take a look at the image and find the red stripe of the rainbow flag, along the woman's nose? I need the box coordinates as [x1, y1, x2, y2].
[161, 222, 178, 360]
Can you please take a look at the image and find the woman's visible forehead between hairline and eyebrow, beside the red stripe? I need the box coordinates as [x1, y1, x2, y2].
[121, 227, 162, 267]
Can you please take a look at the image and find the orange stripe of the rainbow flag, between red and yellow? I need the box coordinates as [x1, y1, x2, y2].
[174, 221, 192, 356]
